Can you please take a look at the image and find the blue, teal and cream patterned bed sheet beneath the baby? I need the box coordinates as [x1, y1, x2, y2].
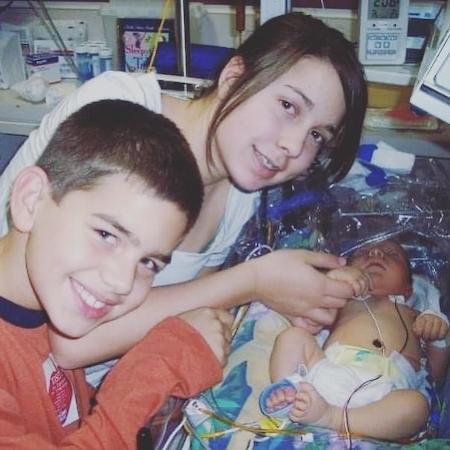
[183, 302, 450, 450]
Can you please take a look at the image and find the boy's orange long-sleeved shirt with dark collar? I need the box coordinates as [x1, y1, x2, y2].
[0, 298, 221, 450]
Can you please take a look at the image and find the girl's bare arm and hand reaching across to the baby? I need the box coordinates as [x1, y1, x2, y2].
[51, 250, 352, 368]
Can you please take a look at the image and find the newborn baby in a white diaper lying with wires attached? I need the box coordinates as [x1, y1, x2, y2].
[261, 240, 448, 439]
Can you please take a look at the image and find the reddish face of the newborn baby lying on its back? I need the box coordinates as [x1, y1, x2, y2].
[349, 240, 411, 297]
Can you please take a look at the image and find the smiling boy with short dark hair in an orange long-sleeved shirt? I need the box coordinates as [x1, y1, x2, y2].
[0, 100, 231, 449]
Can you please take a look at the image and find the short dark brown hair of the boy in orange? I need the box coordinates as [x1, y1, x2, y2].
[36, 100, 203, 228]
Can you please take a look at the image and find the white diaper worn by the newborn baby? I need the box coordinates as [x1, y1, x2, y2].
[306, 343, 430, 408]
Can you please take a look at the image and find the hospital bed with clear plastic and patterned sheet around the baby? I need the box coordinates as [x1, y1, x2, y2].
[140, 149, 450, 450]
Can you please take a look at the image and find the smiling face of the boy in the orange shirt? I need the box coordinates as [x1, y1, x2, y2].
[13, 168, 186, 337]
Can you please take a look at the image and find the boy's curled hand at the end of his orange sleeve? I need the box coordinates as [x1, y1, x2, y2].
[179, 308, 234, 367]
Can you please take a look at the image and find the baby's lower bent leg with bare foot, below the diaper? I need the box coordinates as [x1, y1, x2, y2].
[289, 383, 429, 440]
